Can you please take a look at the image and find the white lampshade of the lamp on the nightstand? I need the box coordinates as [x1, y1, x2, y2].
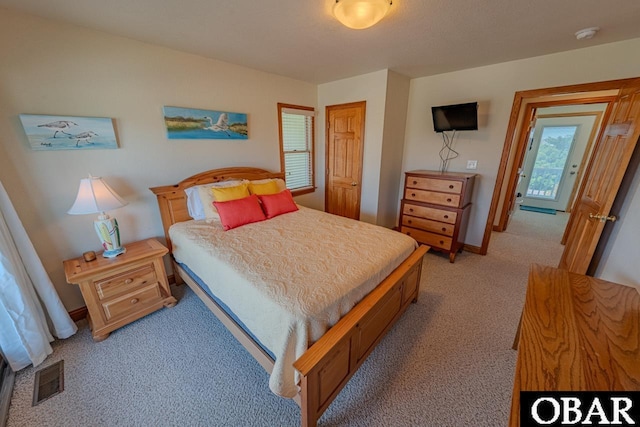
[67, 176, 127, 215]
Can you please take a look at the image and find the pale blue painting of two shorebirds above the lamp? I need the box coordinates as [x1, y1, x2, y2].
[20, 114, 118, 150]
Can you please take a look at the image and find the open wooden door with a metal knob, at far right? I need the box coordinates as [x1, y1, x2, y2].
[559, 79, 640, 274]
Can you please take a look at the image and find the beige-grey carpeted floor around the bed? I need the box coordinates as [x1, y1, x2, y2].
[8, 211, 567, 427]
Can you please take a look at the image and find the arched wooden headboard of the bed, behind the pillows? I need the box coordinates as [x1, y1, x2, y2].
[149, 167, 284, 251]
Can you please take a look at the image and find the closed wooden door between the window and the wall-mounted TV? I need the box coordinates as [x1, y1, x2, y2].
[325, 101, 366, 219]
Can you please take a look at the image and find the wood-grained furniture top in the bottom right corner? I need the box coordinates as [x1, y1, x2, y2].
[510, 264, 640, 426]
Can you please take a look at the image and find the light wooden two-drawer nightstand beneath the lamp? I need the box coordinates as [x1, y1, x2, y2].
[64, 239, 177, 341]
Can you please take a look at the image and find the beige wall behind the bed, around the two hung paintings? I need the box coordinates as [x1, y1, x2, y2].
[0, 9, 317, 310]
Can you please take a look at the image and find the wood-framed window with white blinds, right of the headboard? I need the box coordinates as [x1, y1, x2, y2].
[278, 103, 315, 196]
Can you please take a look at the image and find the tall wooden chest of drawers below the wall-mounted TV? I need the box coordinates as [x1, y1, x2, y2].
[400, 170, 476, 262]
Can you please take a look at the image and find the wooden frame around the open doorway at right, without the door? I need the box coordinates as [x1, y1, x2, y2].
[479, 78, 636, 255]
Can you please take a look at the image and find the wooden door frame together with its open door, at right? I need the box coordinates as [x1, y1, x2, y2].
[480, 79, 640, 272]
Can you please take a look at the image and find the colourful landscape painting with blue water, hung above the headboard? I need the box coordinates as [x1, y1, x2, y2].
[163, 107, 249, 139]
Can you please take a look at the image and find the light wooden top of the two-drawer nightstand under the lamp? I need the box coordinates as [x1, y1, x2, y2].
[63, 239, 169, 284]
